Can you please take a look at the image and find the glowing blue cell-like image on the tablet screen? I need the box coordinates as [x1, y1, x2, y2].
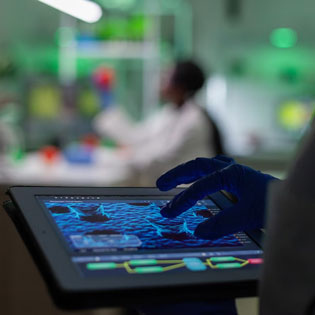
[43, 200, 242, 251]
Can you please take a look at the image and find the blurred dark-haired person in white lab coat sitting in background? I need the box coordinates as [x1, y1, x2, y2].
[95, 60, 222, 185]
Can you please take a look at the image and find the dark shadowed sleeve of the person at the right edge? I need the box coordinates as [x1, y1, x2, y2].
[260, 126, 315, 315]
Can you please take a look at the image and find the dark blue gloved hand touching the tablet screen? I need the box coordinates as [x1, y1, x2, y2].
[156, 156, 276, 240]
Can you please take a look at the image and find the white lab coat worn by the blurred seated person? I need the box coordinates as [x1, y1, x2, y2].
[95, 101, 215, 185]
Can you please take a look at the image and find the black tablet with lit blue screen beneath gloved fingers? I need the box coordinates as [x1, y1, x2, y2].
[5, 187, 263, 309]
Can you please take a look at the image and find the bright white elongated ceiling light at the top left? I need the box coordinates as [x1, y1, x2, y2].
[38, 0, 102, 23]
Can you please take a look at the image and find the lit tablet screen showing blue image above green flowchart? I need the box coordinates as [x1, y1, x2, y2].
[37, 196, 262, 276]
